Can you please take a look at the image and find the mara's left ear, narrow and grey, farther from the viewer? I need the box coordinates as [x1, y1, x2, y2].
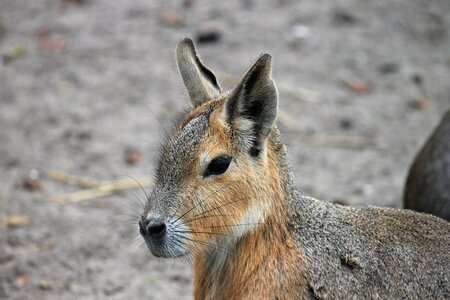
[176, 38, 220, 106]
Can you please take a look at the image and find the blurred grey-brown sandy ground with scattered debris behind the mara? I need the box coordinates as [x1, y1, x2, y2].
[0, 0, 450, 299]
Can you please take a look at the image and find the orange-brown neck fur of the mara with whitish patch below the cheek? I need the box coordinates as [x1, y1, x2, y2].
[194, 128, 303, 299]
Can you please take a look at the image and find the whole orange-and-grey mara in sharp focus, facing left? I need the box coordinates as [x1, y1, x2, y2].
[139, 39, 450, 299]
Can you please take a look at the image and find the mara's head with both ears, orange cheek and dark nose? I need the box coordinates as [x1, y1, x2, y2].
[139, 39, 283, 257]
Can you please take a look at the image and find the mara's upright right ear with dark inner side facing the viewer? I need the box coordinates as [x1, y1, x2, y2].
[226, 54, 278, 156]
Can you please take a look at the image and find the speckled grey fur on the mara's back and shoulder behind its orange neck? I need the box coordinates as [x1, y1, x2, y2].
[272, 130, 450, 299]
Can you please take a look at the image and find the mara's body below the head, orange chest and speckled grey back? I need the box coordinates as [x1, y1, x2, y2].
[195, 198, 450, 300]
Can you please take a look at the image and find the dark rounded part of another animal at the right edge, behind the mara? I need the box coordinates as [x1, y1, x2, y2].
[404, 110, 450, 221]
